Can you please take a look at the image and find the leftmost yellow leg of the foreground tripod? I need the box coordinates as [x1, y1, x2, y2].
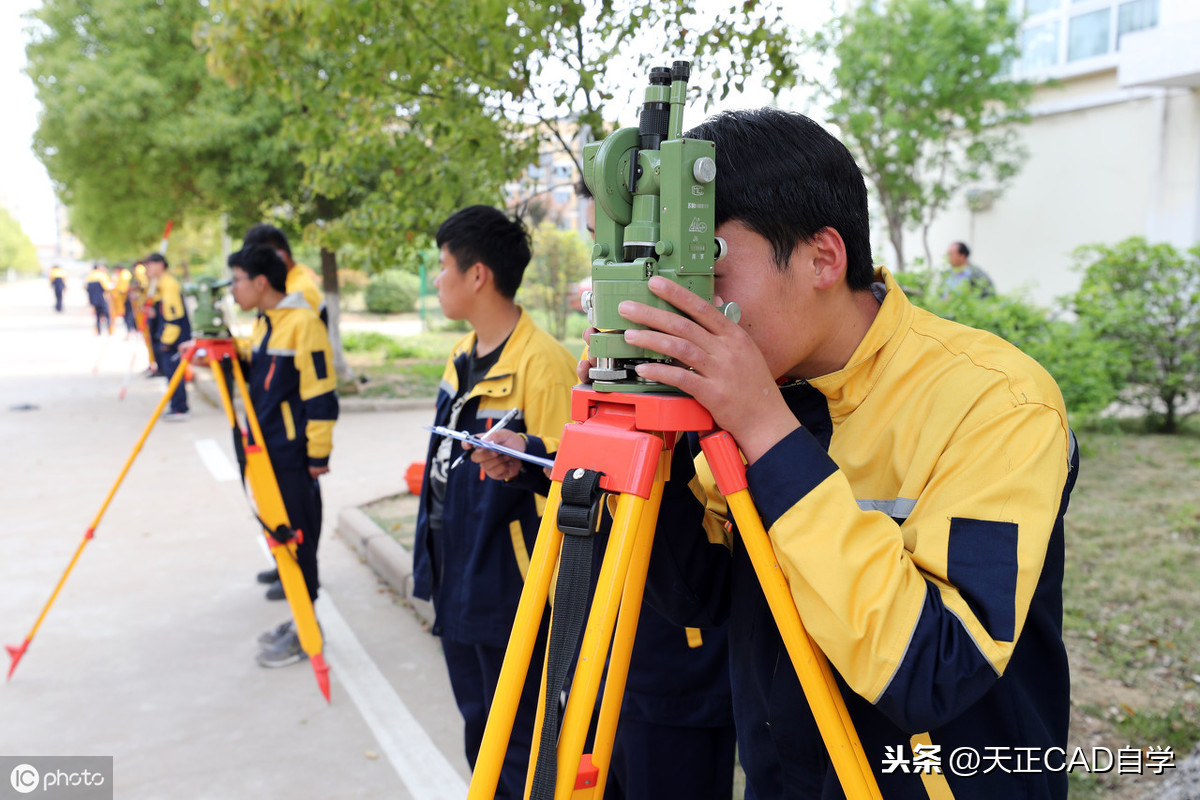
[467, 481, 563, 800]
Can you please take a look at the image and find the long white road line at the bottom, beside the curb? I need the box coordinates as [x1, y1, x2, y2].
[317, 591, 468, 800]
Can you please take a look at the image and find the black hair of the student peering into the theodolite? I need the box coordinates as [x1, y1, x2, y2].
[684, 108, 875, 290]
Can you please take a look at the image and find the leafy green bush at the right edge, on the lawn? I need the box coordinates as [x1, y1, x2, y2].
[1074, 236, 1200, 433]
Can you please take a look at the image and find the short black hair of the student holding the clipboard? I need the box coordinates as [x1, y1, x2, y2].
[437, 205, 530, 300]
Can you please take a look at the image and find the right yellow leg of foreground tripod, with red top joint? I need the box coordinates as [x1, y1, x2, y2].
[702, 433, 883, 800]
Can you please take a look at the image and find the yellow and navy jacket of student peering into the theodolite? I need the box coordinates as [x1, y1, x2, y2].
[648, 270, 1078, 800]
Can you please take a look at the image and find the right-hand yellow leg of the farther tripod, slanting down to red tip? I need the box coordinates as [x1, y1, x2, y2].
[212, 357, 330, 702]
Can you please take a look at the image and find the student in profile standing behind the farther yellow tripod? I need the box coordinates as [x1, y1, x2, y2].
[229, 246, 337, 667]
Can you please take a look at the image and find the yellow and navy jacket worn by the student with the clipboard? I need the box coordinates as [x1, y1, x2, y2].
[413, 309, 576, 646]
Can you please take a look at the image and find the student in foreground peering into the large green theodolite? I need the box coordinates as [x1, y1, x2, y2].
[559, 108, 1079, 800]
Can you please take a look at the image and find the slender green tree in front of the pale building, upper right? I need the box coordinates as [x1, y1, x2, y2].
[810, 0, 1032, 270]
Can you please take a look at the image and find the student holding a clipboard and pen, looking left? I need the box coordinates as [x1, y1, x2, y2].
[413, 205, 575, 798]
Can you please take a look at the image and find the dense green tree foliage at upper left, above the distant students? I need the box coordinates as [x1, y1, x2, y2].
[26, 0, 299, 258]
